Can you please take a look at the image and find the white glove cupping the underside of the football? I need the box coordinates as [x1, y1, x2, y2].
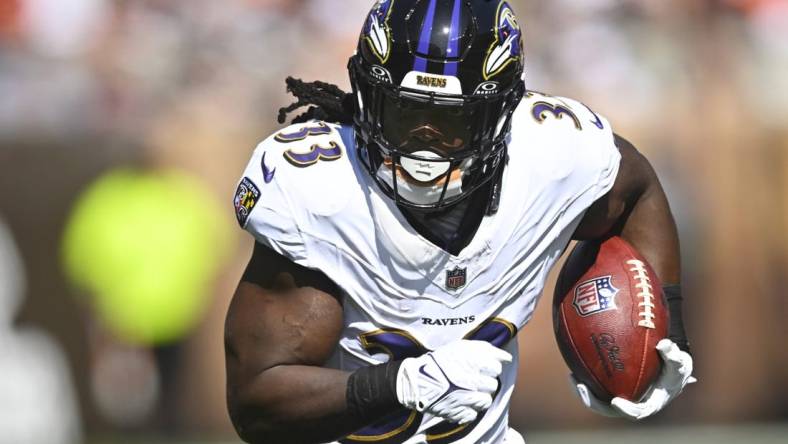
[569, 339, 697, 421]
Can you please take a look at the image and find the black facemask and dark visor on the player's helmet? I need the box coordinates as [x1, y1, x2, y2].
[349, 56, 524, 210]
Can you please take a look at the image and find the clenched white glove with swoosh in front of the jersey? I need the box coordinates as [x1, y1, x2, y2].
[397, 340, 512, 424]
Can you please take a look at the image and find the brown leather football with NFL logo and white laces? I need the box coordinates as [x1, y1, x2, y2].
[553, 237, 669, 402]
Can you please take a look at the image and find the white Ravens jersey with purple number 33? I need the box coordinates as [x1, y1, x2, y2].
[235, 93, 620, 444]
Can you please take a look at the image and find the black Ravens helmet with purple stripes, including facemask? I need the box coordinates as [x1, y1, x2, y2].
[348, 0, 525, 210]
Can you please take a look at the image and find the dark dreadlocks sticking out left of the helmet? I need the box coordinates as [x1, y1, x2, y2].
[277, 77, 353, 124]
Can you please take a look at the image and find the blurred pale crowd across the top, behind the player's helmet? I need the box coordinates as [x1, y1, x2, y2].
[0, 0, 788, 136]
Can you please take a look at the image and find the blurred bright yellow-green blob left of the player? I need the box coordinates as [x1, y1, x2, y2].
[62, 169, 230, 345]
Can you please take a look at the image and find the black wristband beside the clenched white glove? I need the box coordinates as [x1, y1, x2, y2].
[345, 361, 402, 422]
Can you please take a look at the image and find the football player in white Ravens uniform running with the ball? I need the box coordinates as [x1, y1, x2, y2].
[225, 0, 692, 444]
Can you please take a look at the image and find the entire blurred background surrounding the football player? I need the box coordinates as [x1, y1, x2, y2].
[0, 0, 788, 444]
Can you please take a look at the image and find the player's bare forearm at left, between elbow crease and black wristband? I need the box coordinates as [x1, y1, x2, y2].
[228, 365, 401, 444]
